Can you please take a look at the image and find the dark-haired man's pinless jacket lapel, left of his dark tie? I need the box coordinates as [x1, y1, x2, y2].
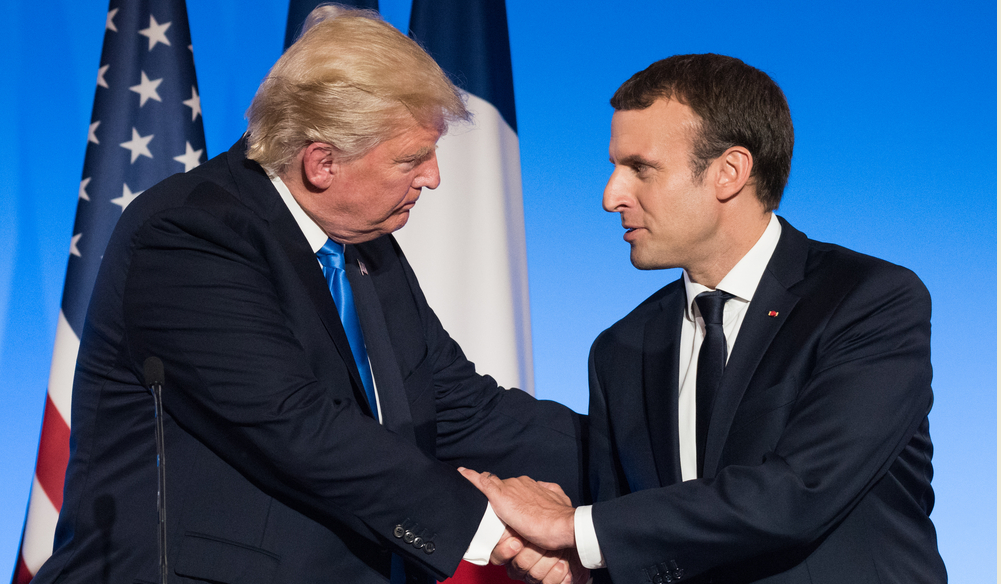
[643, 286, 685, 486]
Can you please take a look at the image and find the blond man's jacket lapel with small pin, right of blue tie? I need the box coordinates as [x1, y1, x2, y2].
[344, 245, 416, 443]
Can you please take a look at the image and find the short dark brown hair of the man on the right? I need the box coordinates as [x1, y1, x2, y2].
[612, 53, 794, 210]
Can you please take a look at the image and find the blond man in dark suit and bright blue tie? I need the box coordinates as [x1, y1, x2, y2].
[35, 7, 581, 584]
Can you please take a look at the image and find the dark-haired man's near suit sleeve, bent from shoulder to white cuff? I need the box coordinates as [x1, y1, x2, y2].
[592, 263, 932, 582]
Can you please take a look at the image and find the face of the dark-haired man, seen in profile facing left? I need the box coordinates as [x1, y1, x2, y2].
[602, 99, 720, 271]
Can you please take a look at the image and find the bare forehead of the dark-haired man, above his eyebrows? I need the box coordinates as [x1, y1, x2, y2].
[611, 99, 699, 157]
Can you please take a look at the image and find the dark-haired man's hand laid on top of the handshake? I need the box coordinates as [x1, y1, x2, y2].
[459, 469, 576, 556]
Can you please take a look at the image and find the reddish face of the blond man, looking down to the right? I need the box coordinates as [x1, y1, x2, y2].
[299, 125, 441, 243]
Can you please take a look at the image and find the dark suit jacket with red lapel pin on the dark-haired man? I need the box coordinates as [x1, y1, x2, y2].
[589, 220, 946, 584]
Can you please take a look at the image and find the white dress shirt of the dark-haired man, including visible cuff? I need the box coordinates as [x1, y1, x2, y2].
[574, 213, 782, 569]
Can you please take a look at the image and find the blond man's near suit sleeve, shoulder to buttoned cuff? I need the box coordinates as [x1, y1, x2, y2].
[123, 202, 485, 577]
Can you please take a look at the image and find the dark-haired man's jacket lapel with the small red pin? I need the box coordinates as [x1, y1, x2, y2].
[703, 217, 807, 478]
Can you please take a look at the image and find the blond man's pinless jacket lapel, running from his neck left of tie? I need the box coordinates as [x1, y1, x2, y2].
[228, 139, 374, 417]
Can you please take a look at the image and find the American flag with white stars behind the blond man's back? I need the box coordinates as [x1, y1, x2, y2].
[12, 0, 207, 584]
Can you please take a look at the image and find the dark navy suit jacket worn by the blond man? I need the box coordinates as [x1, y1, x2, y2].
[35, 142, 582, 584]
